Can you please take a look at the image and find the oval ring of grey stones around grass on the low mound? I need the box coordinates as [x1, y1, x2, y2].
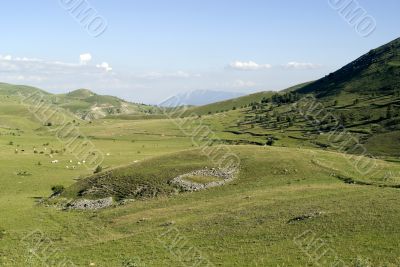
[171, 168, 237, 192]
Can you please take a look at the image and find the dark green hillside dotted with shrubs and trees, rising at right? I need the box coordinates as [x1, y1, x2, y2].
[177, 39, 400, 159]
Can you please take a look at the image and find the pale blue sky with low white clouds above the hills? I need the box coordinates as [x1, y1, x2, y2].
[0, 0, 400, 103]
